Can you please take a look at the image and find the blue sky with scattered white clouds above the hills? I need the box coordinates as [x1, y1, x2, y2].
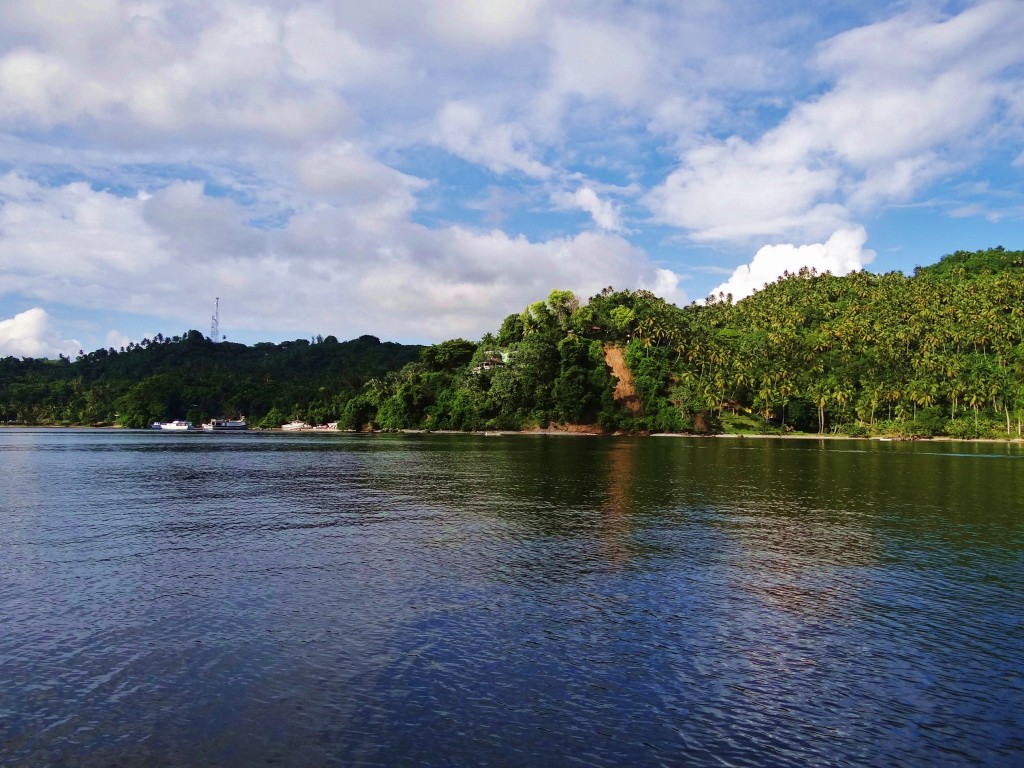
[0, 0, 1024, 357]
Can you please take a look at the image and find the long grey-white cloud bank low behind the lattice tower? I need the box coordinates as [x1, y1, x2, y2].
[0, 173, 685, 346]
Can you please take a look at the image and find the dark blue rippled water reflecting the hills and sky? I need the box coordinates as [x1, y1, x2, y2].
[0, 429, 1024, 766]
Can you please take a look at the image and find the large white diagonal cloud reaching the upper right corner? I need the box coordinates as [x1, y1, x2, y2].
[646, 0, 1024, 242]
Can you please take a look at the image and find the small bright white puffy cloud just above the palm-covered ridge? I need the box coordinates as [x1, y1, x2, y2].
[711, 227, 876, 301]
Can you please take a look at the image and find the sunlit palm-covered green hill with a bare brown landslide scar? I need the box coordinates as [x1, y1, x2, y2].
[343, 248, 1024, 437]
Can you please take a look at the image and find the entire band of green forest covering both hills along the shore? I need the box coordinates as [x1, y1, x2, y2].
[0, 248, 1024, 437]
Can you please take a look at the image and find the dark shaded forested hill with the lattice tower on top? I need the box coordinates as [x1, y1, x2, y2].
[0, 331, 422, 427]
